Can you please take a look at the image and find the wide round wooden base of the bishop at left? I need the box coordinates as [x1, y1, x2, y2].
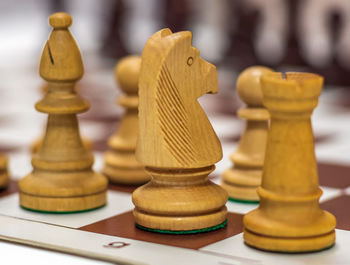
[19, 172, 107, 212]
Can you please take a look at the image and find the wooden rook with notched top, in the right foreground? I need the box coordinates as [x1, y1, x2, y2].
[243, 73, 336, 252]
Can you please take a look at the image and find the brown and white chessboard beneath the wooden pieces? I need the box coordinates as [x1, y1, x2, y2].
[0, 53, 350, 265]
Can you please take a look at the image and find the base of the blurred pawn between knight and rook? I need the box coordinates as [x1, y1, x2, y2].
[221, 168, 262, 202]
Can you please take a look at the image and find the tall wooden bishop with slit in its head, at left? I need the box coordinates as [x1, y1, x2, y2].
[19, 13, 107, 212]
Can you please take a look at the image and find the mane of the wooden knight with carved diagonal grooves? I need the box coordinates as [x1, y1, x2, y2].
[139, 29, 195, 166]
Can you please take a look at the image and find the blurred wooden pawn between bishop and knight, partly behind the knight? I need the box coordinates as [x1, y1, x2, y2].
[103, 56, 150, 185]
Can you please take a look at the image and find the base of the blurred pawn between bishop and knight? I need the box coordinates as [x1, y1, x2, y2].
[103, 152, 151, 185]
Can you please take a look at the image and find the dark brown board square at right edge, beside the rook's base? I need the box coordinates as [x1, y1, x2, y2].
[321, 195, 350, 229]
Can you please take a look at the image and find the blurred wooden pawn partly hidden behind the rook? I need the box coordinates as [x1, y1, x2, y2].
[222, 66, 273, 202]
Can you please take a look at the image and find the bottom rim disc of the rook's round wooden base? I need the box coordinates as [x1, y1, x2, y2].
[243, 229, 335, 253]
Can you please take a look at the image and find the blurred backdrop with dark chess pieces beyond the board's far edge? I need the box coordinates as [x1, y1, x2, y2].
[0, 0, 350, 85]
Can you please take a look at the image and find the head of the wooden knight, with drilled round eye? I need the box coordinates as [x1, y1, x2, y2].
[140, 29, 218, 99]
